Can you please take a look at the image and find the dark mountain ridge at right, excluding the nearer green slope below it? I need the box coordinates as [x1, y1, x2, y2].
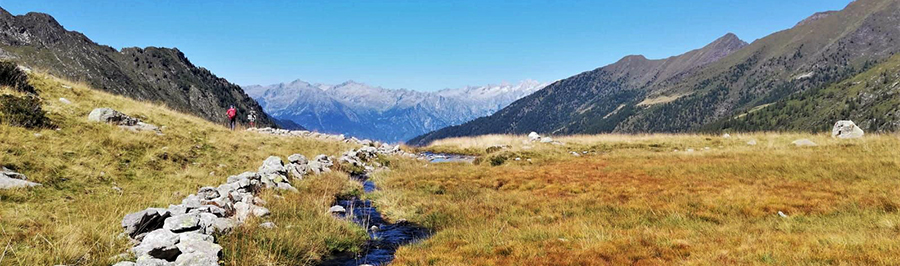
[411, 0, 900, 144]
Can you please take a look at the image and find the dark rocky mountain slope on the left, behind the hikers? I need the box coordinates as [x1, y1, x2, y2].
[0, 6, 274, 126]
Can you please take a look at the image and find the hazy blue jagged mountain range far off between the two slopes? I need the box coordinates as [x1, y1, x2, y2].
[243, 80, 547, 142]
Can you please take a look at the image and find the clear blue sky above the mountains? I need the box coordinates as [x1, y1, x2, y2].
[0, 0, 850, 91]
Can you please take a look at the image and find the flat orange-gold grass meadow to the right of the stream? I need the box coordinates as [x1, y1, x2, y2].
[374, 134, 900, 265]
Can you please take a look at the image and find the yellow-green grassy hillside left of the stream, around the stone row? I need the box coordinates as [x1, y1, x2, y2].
[0, 71, 366, 265]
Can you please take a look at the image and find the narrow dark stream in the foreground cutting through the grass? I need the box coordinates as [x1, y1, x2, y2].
[322, 175, 431, 266]
